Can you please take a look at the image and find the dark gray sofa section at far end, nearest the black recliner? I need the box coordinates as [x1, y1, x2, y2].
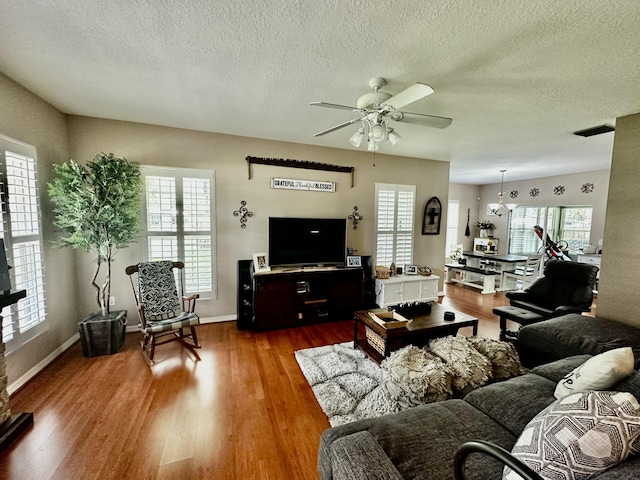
[518, 313, 640, 369]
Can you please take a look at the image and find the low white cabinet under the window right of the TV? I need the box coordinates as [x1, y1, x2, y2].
[376, 275, 440, 308]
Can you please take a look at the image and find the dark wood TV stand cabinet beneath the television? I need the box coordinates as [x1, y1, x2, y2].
[253, 267, 364, 330]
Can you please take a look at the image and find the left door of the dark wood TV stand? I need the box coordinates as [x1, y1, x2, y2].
[254, 275, 297, 330]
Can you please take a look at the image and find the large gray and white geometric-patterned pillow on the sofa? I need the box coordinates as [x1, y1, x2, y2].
[502, 392, 640, 480]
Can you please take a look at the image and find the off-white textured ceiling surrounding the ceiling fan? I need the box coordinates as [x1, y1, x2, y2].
[0, 0, 640, 184]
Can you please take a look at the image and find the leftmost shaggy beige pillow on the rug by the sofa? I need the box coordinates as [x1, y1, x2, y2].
[380, 345, 451, 408]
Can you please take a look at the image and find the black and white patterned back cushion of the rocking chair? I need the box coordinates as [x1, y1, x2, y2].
[138, 260, 182, 320]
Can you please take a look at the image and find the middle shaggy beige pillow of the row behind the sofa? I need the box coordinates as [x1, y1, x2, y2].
[429, 335, 493, 394]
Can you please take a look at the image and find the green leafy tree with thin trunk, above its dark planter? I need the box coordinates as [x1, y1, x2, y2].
[48, 153, 142, 315]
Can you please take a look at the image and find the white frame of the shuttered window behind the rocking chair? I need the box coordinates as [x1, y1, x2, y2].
[141, 165, 218, 299]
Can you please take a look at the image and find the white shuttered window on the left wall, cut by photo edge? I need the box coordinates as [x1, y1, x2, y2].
[0, 136, 48, 352]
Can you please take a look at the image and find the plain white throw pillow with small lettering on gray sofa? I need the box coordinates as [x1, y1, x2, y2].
[554, 347, 634, 399]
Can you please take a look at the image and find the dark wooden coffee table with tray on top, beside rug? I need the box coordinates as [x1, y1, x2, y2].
[353, 303, 478, 363]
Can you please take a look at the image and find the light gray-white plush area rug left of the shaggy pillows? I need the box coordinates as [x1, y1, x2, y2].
[295, 342, 399, 427]
